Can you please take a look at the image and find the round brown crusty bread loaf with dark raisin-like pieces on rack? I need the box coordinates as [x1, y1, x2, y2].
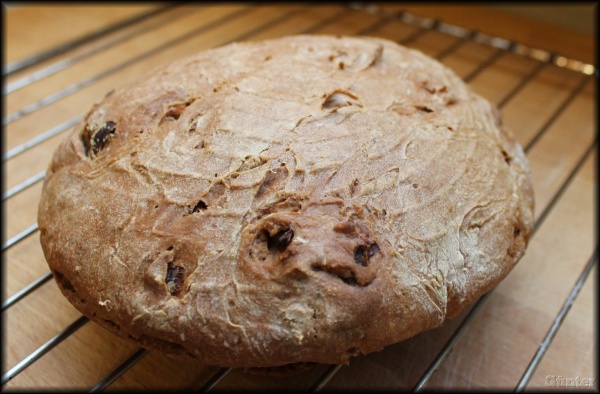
[39, 36, 533, 368]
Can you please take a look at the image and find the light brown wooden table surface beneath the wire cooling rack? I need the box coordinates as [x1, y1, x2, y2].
[2, 3, 598, 390]
